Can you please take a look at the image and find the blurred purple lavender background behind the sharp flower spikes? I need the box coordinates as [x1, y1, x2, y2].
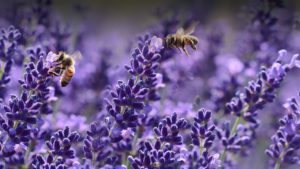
[0, 0, 300, 169]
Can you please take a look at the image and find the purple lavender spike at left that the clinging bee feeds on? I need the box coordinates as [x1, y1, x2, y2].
[1, 53, 53, 161]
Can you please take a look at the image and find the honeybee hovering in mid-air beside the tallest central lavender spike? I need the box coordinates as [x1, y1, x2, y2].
[166, 23, 199, 56]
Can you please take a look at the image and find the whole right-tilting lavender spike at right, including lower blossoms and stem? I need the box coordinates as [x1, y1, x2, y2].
[212, 50, 299, 168]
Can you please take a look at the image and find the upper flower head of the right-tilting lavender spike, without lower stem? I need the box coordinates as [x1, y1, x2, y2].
[226, 50, 300, 124]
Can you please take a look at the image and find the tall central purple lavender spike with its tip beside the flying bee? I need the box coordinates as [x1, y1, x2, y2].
[106, 35, 161, 142]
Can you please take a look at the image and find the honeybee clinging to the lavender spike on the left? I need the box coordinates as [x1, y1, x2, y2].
[48, 51, 81, 87]
